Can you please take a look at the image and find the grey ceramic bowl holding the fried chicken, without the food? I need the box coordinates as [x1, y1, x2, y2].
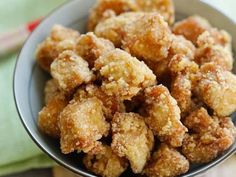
[13, 0, 236, 177]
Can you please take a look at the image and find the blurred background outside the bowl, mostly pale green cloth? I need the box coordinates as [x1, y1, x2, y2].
[0, 0, 236, 177]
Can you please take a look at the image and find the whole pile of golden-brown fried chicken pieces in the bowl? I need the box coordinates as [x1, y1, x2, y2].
[36, 0, 236, 177]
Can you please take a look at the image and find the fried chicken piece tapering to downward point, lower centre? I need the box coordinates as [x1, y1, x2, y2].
[111, 113, 154, 173]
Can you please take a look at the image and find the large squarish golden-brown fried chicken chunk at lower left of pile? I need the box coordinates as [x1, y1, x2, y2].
[59, 97, 110, 154]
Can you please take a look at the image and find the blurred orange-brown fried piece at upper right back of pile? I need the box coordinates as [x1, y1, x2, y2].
[172, 15, 211, 45]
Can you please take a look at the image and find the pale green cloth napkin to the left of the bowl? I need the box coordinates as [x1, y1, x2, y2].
[0, 0, 65, 176]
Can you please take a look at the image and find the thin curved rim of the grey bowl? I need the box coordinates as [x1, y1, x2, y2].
[13, 0, 236, 177]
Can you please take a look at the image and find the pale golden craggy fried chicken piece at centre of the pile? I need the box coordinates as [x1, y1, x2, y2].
[95, 49, 156, 100]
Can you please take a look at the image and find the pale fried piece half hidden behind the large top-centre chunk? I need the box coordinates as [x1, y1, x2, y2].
[94, 12, 144, 47]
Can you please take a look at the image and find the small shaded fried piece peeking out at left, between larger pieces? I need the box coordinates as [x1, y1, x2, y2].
[44, 79, 61, 104]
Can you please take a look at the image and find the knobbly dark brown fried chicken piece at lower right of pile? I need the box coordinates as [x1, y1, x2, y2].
[182, 108, 236, 163]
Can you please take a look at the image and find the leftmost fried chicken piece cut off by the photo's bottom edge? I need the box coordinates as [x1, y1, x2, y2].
[83, 145, 128, 177]
